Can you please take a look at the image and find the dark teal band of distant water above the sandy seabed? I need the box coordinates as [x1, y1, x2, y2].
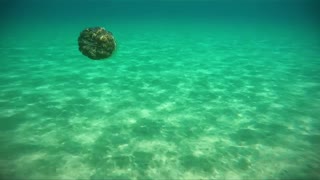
[1, 0, 319, 23]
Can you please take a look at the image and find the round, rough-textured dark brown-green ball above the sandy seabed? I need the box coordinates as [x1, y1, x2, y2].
[78, 27, 116, 60]
